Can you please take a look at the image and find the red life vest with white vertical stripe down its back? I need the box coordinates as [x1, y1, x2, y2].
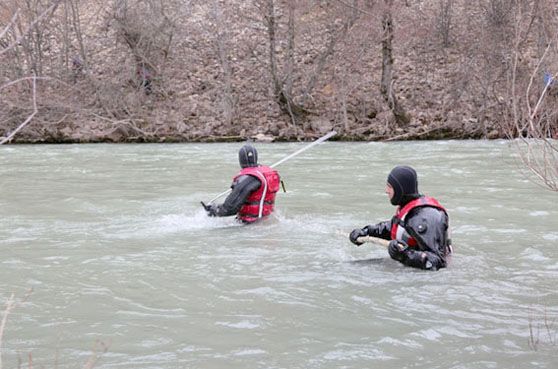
[233, 165, 280, 223]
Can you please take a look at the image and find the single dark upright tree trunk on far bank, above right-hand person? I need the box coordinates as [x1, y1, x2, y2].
[380, 0, 410, 126]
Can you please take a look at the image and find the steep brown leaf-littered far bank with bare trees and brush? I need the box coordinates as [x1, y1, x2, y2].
[0, 0, 558, 142]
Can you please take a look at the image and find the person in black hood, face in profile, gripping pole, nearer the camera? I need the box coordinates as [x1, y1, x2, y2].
[349, 166, 452, 270]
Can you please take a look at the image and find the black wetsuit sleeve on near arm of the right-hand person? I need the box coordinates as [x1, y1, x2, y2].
[389, 207, 449, 270]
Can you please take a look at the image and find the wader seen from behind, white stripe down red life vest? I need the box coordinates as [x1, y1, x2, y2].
[204, 144, 281, 223]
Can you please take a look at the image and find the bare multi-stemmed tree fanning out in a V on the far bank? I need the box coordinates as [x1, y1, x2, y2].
[250, 0, 359, 126]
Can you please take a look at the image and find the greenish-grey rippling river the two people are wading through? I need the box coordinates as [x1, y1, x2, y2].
[0, 141, 558, 369]
